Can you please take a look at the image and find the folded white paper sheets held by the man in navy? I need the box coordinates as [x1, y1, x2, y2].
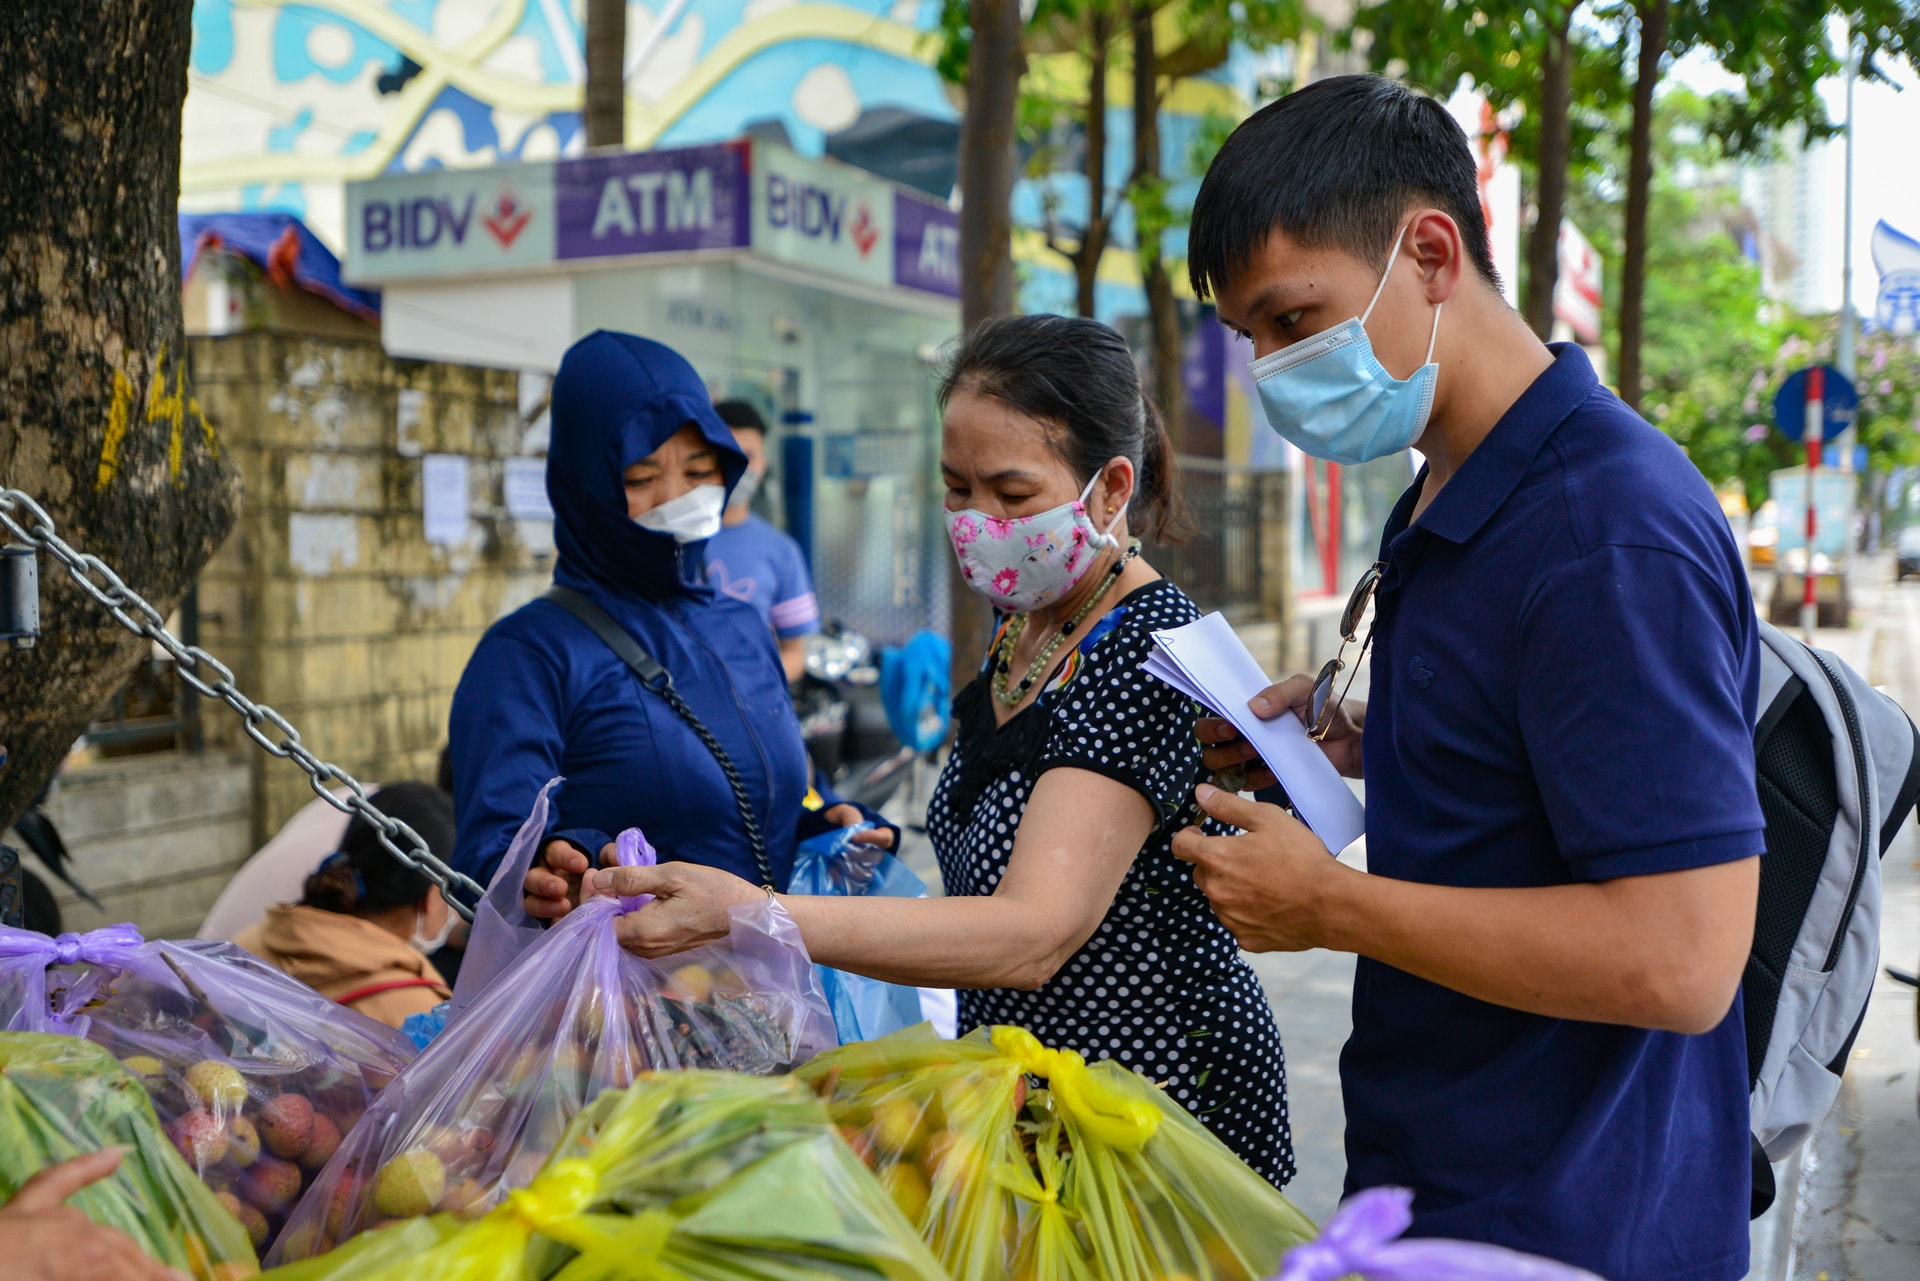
[1140, 613, 1367, 855]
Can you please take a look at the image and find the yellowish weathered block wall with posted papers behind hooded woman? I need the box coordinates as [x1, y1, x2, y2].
[192, 332, 551, 841]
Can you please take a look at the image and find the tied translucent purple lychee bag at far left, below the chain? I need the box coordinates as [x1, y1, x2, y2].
[0, 926, 413, 1246]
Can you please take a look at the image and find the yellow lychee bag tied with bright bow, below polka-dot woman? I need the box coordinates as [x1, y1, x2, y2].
[799, 1026, 1315, 1281]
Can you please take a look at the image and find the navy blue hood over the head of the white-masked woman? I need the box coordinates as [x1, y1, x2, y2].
[547, 328, 747, 597]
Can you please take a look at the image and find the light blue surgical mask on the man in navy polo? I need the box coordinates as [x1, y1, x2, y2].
[1248, 227, 1440, 467]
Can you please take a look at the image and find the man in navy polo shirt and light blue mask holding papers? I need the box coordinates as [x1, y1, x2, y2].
[1175, 77, 1764, 1281]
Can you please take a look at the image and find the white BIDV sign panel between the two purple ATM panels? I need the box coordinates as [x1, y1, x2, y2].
[753, 144, 893, 284]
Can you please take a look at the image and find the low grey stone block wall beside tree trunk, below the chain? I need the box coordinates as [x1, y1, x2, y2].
[8, 751, 253, 937]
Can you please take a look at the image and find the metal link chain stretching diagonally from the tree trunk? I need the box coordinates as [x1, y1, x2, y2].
[0, 490, 486, 922]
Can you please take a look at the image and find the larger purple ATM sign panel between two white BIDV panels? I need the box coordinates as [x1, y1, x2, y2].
[553, 142, 753, 259]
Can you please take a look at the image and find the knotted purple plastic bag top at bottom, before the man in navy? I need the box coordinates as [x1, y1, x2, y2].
[1275, 1187, 1603, 1281]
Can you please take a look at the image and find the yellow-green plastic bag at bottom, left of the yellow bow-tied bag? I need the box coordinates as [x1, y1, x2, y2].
[263, 1070, 945, 1281]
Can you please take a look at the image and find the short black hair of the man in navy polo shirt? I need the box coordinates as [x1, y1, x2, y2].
[1187, 75, 1500, 298]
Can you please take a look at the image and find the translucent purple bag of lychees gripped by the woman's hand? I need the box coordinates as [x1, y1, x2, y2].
[267, 810, 833, 1264]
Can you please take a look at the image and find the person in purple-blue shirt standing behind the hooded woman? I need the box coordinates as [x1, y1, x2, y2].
[707, 399, 820, 682]
